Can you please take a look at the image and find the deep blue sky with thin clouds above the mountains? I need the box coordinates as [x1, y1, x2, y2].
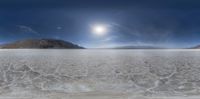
[0, 0, 200, 48]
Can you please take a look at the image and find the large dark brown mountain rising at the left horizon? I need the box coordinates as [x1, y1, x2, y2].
[0, 39, 83, 49]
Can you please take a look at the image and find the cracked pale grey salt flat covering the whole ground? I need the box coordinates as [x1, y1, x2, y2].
[0, 49, 200, 99]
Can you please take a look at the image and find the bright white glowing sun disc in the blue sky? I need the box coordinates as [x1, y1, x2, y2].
[92, 25, 108, 36]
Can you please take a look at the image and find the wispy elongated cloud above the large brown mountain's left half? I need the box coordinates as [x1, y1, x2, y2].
[17, 25, 40, 35]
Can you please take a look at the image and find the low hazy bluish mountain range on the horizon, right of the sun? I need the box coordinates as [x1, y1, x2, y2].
[113, 46, 165, 49]
